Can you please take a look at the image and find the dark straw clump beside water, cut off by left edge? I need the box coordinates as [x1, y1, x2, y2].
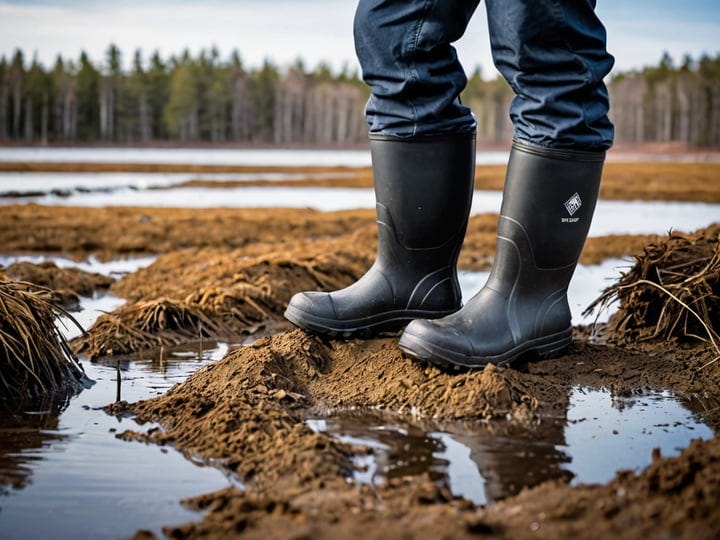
[0, 280, 83, 405]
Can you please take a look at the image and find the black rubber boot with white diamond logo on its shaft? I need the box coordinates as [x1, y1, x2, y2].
[400, 141, 605, 369]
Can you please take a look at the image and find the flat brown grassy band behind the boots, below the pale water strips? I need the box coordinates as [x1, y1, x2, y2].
[0, 204, 654, 270]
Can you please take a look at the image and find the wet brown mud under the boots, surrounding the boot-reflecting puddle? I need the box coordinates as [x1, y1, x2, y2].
[123, 330, 720, 538]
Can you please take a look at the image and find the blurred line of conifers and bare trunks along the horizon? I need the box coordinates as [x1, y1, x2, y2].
[0, 45, 720, 146]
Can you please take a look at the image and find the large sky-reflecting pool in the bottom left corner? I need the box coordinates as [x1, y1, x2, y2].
[0, 343, 238, 538]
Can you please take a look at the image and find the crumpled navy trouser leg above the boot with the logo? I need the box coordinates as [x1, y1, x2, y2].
[486, 0, 614, 151]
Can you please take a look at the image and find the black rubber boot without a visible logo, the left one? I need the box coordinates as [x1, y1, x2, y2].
[285, 133, 475, 338]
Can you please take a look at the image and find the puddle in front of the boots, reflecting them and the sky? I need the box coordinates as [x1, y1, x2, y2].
[307, 387, 713, 504]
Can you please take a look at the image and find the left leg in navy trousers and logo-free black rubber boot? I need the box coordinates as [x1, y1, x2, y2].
[285, 0, 478, 337]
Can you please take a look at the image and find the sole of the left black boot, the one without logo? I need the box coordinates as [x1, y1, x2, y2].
[284, 306, 460, 339]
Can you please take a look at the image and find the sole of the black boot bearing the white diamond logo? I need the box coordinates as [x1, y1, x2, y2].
[398, 327, 572, 371]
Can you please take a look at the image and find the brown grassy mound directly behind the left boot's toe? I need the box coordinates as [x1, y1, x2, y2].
[73, 237, 372, 359]
